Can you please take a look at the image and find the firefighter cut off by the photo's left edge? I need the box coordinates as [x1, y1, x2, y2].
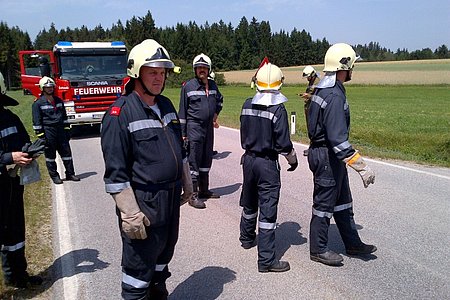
[0, 73, 42, 288]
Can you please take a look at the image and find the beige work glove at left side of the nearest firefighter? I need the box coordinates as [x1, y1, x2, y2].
[112, 187, 150, 240]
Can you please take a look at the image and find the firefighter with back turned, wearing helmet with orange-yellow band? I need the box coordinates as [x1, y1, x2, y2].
[239, 63, 298, 272]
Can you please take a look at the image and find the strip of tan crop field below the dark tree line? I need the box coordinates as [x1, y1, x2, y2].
[223, 59, 450, 85]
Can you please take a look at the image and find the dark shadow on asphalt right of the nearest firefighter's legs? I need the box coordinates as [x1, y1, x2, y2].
[169, 267, 236, 300]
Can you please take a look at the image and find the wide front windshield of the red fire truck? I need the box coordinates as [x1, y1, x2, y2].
[60, 55, 127, 80]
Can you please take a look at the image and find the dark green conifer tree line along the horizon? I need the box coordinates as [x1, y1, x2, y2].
[0, 11, 450, 87]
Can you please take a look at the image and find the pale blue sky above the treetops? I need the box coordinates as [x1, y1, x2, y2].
[0, 0, 450, 51]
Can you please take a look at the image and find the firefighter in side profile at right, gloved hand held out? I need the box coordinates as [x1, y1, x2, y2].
[308, 43, 377, 266]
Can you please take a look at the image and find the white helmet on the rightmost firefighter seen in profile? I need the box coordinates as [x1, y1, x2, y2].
[323, 43, 359, 72]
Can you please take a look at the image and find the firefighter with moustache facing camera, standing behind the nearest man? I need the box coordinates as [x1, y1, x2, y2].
[179, 53, 223, 208]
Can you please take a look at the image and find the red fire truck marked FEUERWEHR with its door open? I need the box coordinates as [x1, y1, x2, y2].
[19, 41, 129, 126]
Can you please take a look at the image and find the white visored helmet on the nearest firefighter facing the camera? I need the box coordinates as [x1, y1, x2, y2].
[127, 39, 175, 78]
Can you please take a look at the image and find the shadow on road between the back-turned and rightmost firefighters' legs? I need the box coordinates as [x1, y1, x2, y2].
[275, 222, 307, 259]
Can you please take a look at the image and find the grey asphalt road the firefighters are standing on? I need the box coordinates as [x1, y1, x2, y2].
[53, 127, 450, 300]
